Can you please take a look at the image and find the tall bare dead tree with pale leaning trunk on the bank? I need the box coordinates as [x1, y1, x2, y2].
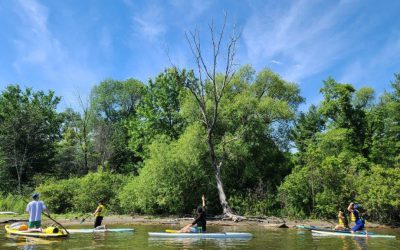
[185, 15, 240, 217]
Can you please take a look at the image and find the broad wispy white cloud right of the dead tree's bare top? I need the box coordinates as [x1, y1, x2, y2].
[243, 0, 358, 81]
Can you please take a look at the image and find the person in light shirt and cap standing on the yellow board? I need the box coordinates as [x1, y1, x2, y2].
[26, 193, 50, 231]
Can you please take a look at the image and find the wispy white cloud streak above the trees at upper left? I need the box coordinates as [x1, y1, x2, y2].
[12, 0, 100, 108]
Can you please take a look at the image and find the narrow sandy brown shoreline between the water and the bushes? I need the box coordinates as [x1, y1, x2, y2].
[0, 215, 396, 228]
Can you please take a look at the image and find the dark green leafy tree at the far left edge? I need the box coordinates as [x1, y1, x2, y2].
[0, 85, 61, 192]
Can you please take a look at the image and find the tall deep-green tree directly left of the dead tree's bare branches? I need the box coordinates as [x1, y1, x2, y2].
[128, 68, 188, 157]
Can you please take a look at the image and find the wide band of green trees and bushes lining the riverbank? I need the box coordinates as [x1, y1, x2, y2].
[0, 66, 400, 223]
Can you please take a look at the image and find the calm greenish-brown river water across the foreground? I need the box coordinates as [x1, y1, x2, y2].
[0, 225, 400, 250]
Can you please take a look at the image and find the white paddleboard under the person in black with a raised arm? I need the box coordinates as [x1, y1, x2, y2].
[149, 230, 253, 239]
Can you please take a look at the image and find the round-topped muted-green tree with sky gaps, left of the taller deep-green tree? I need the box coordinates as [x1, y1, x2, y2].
[90, 79, 145, 172]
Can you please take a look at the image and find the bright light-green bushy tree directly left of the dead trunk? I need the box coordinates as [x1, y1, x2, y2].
[119, 124, 213, 213]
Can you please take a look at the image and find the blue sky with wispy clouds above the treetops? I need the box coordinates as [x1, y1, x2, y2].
[0, 0, 400, 108]
